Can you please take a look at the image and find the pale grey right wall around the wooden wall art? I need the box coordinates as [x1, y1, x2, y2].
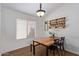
[46, 4, 79, 54]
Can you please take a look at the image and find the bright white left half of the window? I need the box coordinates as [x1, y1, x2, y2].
[16, 19, 27, 39]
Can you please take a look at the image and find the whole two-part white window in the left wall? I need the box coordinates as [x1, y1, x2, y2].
[16, 19, 36, 39]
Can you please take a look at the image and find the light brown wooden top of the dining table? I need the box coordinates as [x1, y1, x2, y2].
[33, 37, 58, 46]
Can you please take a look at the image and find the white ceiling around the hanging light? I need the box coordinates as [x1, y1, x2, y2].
[2, 3, 62, 16]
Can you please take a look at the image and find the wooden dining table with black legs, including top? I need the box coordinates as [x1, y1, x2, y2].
[33, 37, 58, 56]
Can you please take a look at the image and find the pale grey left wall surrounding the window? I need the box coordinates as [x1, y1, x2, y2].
[0, 6, 43, 52]
